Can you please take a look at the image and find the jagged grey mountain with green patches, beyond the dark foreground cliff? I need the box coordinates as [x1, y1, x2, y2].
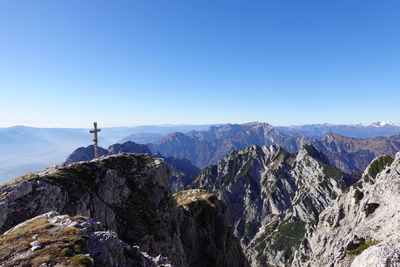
[192, 145, 354, 266]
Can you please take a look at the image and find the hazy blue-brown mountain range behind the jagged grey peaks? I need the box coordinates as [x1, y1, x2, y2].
[147, 123, 400, 173]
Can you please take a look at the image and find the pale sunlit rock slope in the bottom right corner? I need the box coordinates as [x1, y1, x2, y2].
[309, 153, 400, 267]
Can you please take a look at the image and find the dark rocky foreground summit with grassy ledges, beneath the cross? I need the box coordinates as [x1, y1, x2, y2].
[0, 154, 248, 267]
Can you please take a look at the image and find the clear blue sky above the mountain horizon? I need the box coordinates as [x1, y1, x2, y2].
[0, 0, 400, 127]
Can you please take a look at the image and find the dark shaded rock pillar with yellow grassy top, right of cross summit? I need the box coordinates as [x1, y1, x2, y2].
[174, 189, 248, 267]
